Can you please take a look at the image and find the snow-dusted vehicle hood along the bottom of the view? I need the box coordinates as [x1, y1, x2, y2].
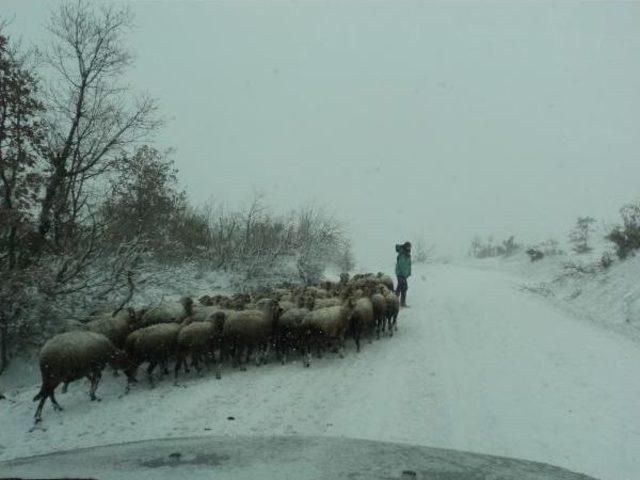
[0, 436, 594, 480]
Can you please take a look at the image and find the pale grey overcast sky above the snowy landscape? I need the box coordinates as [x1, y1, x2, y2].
[0, 0, 640, 264]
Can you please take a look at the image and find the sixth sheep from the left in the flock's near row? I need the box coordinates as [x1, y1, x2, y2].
[302, 299, 355, 366]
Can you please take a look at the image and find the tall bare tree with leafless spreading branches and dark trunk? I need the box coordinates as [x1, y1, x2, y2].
[38, 0, 159, 246]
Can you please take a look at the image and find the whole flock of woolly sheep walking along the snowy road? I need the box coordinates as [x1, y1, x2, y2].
[33, 273, 400, 423]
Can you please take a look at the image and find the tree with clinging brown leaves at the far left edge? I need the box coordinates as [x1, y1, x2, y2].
[0, 22, 42, 372]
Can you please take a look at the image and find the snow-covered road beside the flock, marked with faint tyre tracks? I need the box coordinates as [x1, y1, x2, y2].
[0, 266, 640, 480]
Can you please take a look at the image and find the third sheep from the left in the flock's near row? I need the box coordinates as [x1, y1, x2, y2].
[174, 311, 226, 379]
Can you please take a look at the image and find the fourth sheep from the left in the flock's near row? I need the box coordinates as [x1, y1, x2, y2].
[223, 299, 281, 370]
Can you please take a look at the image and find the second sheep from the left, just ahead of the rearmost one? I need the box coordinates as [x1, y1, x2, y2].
[125, 322, 183, 392]
